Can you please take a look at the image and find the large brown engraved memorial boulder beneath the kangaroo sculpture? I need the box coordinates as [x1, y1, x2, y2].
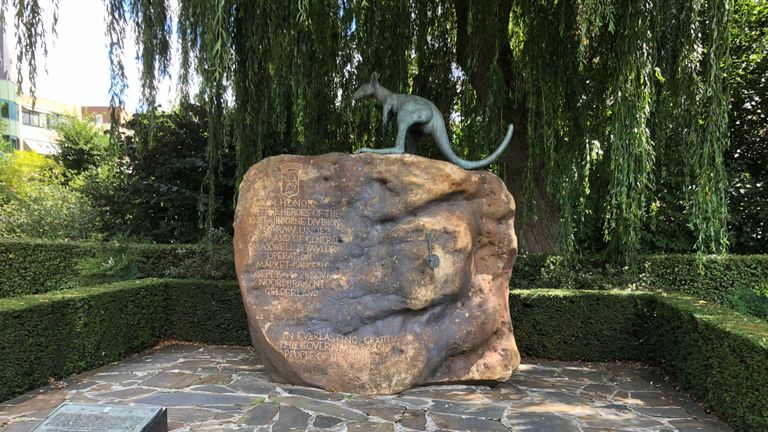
[234, 153, 520, 394]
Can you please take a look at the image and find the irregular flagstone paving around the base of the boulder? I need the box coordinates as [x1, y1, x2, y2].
[0, 344, 732, 432]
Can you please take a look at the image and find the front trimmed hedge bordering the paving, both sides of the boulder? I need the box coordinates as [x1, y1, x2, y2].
[0, 279, 768, 431]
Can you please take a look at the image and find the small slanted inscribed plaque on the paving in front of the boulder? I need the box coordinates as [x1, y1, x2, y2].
[32, 403, 168, 432]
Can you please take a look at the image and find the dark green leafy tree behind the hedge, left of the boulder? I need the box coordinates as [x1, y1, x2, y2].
[85, 104, 235, 243]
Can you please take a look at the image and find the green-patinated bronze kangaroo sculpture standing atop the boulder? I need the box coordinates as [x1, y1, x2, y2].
[352, 72, 513, 170]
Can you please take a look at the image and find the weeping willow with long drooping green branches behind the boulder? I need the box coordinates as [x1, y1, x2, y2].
[3, 0, 730, 261]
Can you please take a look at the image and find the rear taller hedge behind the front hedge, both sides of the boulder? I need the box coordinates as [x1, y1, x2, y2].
[0, 240, 768, 319]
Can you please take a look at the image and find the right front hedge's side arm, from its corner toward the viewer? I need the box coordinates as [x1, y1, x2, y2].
[646, 295, 768, 431]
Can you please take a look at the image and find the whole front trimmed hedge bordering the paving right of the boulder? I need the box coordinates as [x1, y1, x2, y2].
[510, 290, 768, 431]
